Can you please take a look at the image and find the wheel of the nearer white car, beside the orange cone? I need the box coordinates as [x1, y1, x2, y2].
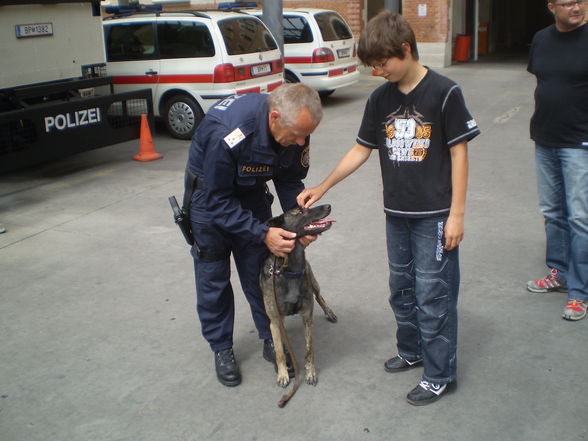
[163, 95, 204, 139]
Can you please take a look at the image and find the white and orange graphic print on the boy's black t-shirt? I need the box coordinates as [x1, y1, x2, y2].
[384, 106, 432, 162]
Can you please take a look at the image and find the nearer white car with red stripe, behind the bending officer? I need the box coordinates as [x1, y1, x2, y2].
[104, 11, 284, 139]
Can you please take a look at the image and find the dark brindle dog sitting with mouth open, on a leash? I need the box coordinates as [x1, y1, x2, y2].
[260, 205, 337, 390]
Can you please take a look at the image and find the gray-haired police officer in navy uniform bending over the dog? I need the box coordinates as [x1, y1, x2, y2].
[186, 83, 322, 386]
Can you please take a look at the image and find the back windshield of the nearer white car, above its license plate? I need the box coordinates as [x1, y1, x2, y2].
[218, 17, 278, 55]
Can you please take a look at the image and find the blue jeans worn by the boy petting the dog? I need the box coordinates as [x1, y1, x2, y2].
[386, 216, 459, 383]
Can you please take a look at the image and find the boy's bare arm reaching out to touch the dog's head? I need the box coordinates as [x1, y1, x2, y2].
[296, 143, 373, 208]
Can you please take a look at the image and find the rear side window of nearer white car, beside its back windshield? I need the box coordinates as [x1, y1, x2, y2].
[157, 21, 214, 59]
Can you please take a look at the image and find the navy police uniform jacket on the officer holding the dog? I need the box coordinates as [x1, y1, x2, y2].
[188, 93, 309, 242]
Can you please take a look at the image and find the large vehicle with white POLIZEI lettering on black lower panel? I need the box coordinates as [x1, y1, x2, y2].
[0, 0, 153, 173]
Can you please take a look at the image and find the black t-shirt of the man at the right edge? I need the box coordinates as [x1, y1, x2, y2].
[527, 25, 588, 148]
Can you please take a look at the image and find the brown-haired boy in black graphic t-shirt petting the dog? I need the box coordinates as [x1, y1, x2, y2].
[297, 10, 480, 406]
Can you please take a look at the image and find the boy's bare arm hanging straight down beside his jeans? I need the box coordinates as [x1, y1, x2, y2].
[445, 141, 468, 250]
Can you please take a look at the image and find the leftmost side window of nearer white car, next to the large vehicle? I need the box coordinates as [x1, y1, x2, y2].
[105, 23, 156, 61]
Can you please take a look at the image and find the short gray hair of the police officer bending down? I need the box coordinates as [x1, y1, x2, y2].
[268, 83, 323, 127]
